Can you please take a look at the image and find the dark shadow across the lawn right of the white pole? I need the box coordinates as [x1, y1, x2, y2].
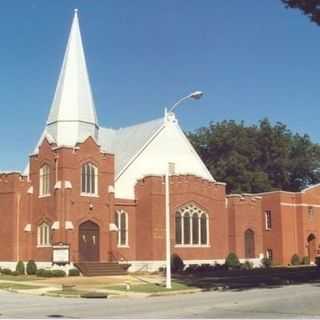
[173, 267, 320, 291]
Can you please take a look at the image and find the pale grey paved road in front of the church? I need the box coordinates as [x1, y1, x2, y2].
[0, 284, 320, 319]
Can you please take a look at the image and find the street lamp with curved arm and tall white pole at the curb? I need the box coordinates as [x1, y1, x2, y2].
[165, 91, 203, 289]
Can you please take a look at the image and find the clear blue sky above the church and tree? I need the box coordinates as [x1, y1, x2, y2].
[0, 0, 320, 170]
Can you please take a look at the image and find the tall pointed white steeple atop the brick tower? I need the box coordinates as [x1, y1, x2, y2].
[46, 9, 99, 146]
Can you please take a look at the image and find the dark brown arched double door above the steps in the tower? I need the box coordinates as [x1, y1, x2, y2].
[79, 221, 99, 261]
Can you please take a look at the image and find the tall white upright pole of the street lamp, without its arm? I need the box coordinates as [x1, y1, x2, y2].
[165, 164, 171, 289]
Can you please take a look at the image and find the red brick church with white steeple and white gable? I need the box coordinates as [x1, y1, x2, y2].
[0, 12, 320, 271]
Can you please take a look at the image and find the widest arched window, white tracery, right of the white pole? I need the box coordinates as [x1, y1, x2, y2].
[175, 204, 209, 247]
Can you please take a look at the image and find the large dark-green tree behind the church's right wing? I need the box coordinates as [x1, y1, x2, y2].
[188, 119, 320, 193]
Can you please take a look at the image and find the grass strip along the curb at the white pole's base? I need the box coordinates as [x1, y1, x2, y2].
[105, 282, 194, 293]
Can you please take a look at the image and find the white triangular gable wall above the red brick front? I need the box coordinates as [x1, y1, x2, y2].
[115, 114, 214, 199]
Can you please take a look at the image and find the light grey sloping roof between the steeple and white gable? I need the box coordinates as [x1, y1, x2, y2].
[98, 118, 164, 176]
